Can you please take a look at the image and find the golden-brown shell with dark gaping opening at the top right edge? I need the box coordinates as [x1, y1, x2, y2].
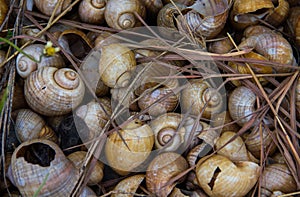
[230, 0, 274, 29]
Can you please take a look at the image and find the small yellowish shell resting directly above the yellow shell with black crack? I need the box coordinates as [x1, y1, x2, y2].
[216, 131, 257, 162]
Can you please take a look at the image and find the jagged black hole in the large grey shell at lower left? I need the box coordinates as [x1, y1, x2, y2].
[16, 142, 55, 167]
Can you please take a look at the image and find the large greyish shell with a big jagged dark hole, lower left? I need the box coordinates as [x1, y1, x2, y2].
[11, 139, 79, 197]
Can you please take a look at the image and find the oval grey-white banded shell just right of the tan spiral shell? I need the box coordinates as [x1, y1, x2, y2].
[228, 86, 256, 126]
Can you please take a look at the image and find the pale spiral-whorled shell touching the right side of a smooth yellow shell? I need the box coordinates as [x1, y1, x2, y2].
[150, 113, 186, 151]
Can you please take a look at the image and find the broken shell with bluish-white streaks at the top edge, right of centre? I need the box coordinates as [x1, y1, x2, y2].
[177, 0, 229, 39]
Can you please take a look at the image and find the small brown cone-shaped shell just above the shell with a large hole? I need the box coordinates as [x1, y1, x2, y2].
[15, 109, 58, 143]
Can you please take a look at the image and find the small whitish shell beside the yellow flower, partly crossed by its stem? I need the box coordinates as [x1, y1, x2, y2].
[16, 44, 65, 78]
